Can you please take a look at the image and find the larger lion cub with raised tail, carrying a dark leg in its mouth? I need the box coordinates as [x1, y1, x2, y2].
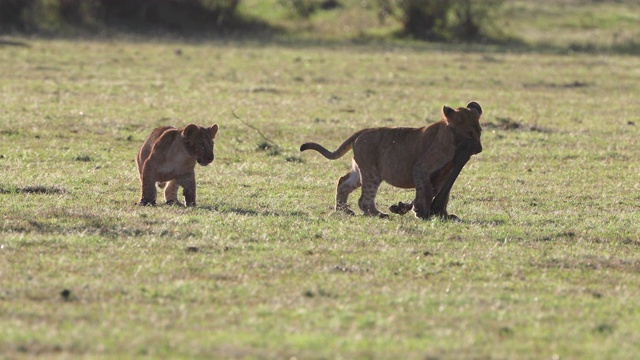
[300, 101, 482, 219]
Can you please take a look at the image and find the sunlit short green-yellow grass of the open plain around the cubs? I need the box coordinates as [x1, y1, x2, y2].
[0, 1, 640, 359]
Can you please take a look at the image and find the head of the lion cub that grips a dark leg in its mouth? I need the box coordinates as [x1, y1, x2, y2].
[442, 101, 482, 155]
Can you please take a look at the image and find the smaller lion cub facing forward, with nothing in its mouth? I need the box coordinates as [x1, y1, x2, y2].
[136, 124, 218, 206]
